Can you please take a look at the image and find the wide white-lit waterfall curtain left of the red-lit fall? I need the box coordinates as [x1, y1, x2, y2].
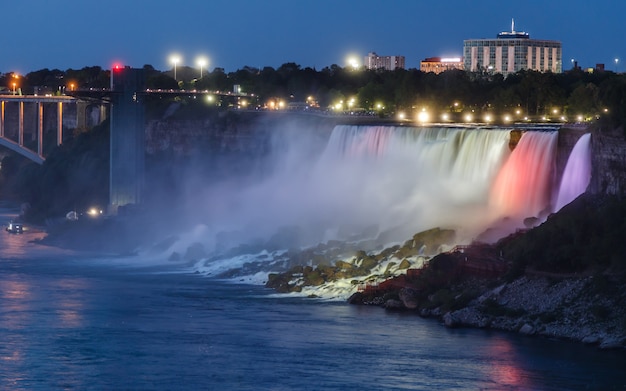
[311, 126, 510, 242]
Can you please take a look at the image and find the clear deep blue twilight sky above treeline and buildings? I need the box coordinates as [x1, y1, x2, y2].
[0, 0, 626, 73]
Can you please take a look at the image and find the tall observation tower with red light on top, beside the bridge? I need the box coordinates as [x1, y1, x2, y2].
[109, 67, 145, 214]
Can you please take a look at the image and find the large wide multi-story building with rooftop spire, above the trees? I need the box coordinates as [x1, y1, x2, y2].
[463, 22, 563, 77]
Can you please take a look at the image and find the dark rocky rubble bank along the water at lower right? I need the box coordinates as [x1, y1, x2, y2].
[349, 274, 626, 349]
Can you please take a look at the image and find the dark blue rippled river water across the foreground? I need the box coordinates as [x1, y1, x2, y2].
[0, 214, 626, 390]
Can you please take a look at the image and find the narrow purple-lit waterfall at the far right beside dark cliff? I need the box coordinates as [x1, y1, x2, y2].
[554, 133, 591, 212]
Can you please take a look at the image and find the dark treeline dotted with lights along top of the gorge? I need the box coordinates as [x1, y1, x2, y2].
[0, 63, 626, 128]
